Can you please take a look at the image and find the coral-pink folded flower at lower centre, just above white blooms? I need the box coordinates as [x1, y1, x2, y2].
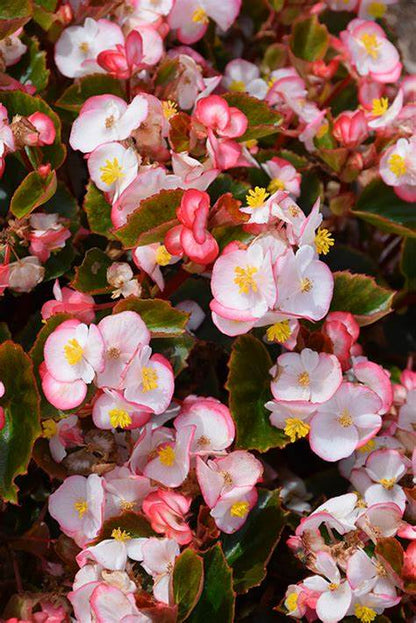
[143, 489, 192, 545]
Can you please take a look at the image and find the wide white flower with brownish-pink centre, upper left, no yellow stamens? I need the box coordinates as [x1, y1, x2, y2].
[69, 95, 148, 153]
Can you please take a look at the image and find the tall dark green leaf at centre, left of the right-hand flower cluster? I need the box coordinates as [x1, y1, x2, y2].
[226, 335, 287, 452]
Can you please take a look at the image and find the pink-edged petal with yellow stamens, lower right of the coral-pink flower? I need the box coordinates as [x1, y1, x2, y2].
[210, 487, 258, 534]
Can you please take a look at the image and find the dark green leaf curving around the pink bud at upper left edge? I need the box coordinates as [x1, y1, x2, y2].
[0, 91, 66, 169]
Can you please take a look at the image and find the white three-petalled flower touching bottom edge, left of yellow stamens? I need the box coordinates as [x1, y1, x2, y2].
[303, 552, 352, 623]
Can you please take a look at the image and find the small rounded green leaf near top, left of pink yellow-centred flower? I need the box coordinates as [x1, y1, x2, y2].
[290, 15, 329, 61]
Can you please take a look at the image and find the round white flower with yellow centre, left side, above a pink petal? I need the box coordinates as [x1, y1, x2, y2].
[44, 320, 104, 383]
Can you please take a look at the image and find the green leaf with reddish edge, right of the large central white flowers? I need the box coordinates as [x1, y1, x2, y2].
[331, 271, 395, 327]
